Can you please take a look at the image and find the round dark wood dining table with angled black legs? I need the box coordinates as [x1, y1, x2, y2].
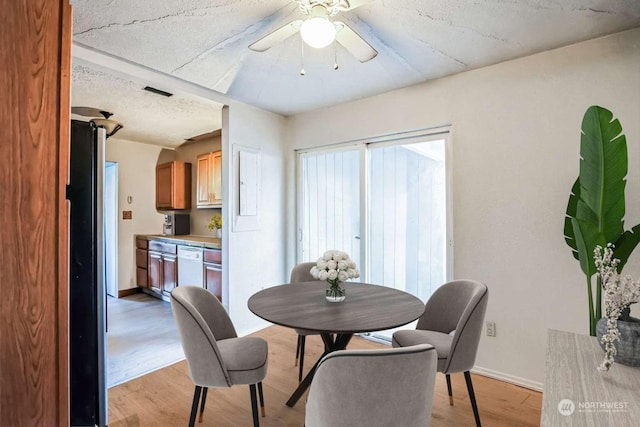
[247, 281, 425, 407]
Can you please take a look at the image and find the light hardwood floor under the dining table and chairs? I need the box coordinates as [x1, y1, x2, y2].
[109, 326, 542, 427]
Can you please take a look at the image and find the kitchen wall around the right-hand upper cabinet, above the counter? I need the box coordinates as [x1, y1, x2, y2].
[176, 136, 224, 237]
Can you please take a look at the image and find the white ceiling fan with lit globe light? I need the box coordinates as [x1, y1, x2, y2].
[249, 0, 378, 62]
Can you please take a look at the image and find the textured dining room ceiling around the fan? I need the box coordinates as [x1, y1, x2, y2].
[72, 0, 640, 115]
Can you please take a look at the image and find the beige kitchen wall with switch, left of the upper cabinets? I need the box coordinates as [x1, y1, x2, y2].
[106, 138, 164, 290]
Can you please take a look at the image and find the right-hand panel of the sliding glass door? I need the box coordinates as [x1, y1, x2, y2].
[367, 140, 446, 301]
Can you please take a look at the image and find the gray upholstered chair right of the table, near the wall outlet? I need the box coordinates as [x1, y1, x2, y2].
[392, 280, 489, 427]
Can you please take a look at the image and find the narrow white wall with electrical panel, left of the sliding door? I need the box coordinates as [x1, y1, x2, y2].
[222, 104, 286, 335]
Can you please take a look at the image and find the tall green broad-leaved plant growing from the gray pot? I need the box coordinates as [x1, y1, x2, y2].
[564, 106, 640, 336]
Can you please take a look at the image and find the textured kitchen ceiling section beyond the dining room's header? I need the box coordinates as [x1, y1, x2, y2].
[71, 59, 222, 147]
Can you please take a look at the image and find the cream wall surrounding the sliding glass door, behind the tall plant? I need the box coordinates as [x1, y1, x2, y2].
[286, 29, 640, 387]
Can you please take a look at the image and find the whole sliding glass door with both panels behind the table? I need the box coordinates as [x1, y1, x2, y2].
[298, 132, 451, 335]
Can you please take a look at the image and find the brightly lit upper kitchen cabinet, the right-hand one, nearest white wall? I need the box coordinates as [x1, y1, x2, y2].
[196, 151, 222, 208]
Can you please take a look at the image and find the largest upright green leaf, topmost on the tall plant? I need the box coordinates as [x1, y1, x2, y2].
[575, 106, 627, 242]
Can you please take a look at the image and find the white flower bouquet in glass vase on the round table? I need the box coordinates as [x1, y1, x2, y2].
[310, 250, 360, 302]
